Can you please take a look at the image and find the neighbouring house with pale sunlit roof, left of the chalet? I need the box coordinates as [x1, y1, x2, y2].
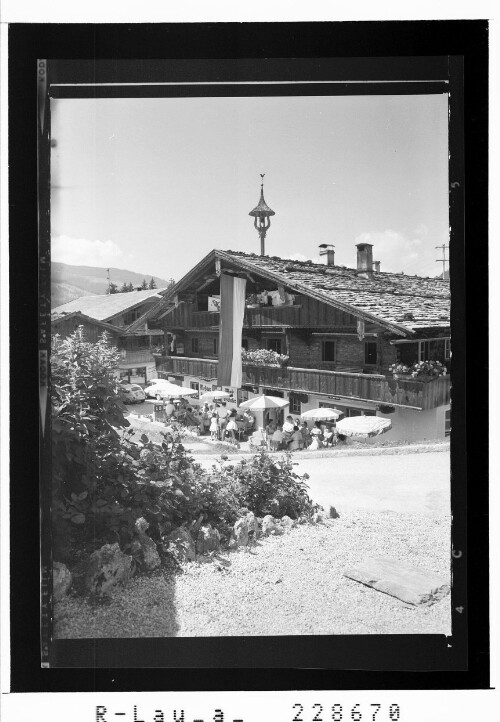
[52, 289, 166, 383]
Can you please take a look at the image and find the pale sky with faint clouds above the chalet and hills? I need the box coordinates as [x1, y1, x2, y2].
[51, 95, 449, 280]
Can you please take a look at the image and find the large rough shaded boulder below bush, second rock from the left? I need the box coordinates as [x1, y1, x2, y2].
[85, 542, 132, 597]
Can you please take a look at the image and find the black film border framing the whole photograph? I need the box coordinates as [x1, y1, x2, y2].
[9, 21, 489, 692]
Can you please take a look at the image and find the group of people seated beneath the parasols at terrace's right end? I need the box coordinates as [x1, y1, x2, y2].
[266, 416, 337, 451]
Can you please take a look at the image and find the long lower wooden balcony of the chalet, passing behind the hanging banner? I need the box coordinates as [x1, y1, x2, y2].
[157, 356, 450, 409]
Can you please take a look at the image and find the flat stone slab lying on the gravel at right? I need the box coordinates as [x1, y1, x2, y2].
[344, 557, 450, 606]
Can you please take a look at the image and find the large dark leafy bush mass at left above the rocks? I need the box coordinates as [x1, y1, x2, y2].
[51, 327, 314, 562]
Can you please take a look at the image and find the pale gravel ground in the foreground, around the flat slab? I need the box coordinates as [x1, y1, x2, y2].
[55, 510, 450, 638]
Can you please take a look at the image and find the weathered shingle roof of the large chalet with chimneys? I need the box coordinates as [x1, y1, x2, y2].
[216, 251, 450, 331]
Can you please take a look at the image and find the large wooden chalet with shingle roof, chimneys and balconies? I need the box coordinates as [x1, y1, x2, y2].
[143, 244, 450, 440]
